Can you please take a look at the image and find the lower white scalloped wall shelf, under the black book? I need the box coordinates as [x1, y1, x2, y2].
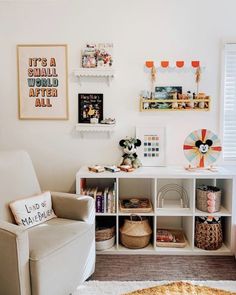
[75, 123, 116, 136]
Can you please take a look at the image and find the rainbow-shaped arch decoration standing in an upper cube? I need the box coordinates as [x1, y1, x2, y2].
[157, 183, 189, 209]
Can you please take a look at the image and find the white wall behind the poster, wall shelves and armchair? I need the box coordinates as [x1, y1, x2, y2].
[0, 0, 236, 191]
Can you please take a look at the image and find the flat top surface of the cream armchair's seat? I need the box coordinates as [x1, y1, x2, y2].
[28, 218, 91, 260]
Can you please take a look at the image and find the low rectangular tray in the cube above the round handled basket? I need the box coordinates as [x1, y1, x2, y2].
[120, 197, 153, 213]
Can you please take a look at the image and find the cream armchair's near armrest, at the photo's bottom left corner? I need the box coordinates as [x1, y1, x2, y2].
[0, 221, 31, 295]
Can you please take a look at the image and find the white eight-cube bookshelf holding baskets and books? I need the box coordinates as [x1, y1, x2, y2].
[76, 167, 236, 255]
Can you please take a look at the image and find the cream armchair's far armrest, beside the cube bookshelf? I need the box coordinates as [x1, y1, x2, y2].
[51, 192, 95, 223]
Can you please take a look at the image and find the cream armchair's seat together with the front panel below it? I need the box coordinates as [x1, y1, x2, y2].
[27, 218, 95, 295]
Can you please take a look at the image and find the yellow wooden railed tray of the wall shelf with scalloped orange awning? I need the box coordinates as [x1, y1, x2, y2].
[140, 96, 211, 112]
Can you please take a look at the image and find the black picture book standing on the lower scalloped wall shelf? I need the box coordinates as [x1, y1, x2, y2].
[78, 93, 103, 123]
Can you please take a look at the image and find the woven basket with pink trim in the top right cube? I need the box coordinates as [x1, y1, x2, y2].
[196, 185, 221, 213]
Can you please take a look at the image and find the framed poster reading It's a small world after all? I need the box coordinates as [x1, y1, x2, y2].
[17, 45, 68, 120]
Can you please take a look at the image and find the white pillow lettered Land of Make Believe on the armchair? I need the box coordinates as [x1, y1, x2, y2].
[10, 192, 56, 228]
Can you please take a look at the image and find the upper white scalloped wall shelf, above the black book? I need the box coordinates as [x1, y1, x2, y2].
[74, 68, 115, 85]
